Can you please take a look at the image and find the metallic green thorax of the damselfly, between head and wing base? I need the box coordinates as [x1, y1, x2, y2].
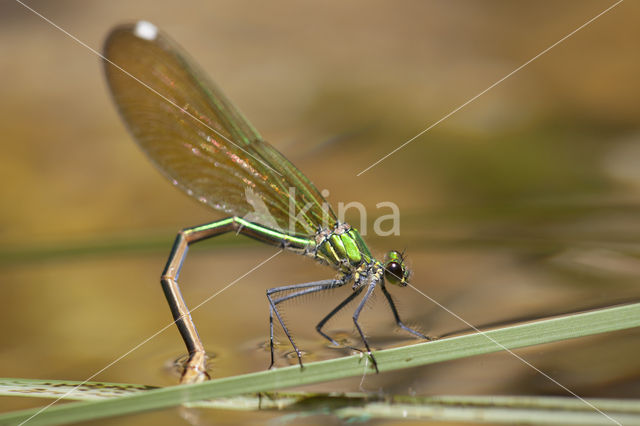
[315, 223, 373, 269]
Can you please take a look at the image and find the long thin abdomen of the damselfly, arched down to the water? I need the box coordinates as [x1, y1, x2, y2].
[161, 217, 308, 383]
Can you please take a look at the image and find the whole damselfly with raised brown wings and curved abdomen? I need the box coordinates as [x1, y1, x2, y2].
[103, 21, 428, 383]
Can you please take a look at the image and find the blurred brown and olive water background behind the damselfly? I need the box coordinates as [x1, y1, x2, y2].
[0, 0, 640, 424]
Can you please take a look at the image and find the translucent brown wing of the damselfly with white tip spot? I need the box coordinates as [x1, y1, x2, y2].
[104, 22, 336, 236]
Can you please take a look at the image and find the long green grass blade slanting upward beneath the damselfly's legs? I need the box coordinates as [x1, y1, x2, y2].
[0, 303, 640, 425]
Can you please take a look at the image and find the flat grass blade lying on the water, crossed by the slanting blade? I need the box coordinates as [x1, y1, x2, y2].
[0, 379, 640, 425]
